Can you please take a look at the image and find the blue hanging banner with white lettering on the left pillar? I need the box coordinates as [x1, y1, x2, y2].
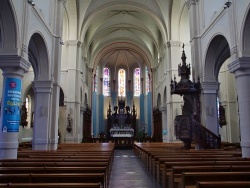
[2, 78, 22, 132]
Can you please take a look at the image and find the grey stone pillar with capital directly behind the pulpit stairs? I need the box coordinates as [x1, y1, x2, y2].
[202, 82, 219, 135]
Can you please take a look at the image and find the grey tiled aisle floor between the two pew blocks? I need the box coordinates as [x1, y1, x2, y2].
[109, 150, 161, 188]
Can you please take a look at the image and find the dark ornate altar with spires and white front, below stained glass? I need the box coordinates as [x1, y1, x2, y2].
[107, 98, 136, 138]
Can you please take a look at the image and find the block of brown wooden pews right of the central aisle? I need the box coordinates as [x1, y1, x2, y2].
[133, 143, 250, 188]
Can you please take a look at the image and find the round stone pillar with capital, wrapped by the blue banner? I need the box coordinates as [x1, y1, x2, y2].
[0, 56, 30, 159]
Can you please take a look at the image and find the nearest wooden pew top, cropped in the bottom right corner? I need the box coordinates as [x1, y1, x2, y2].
[196, 181, 250, 188]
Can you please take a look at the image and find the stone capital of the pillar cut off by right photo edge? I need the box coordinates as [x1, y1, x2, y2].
[227, 57, 250, 75]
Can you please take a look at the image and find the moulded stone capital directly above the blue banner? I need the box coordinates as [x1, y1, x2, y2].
[0, 55, 31, 75]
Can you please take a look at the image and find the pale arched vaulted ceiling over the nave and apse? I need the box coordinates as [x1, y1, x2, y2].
[64, 0, 185, 72]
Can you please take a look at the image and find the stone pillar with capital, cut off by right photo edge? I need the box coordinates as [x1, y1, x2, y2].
[228, 57, 250, 158]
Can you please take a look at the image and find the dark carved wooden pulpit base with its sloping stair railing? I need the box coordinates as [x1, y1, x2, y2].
[175, 115, 221, 149]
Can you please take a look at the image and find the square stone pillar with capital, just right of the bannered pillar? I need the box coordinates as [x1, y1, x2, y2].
[32, 80, 53, 150]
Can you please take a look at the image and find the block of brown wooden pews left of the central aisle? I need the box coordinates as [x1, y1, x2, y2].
[0, 143, 114, 188]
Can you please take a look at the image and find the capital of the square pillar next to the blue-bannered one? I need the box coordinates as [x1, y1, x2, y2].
[32, 80, 53, 93]
